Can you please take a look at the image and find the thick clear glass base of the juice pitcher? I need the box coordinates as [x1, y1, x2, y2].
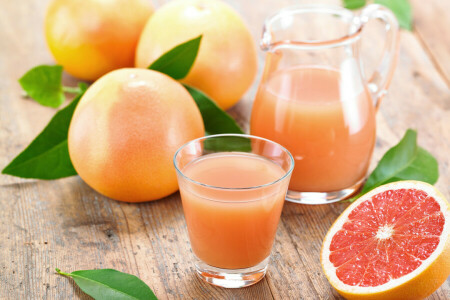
[286, 178, 364, 204]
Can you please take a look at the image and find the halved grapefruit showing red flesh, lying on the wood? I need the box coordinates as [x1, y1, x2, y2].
[321, 181, 450, 300]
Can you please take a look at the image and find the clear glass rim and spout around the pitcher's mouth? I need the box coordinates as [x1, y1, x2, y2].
[260, 4, 363, 51]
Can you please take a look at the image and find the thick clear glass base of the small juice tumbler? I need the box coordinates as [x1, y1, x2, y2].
[195, 257, 269, 288]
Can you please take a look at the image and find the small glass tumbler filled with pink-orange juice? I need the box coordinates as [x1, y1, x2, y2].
[174, 134, 294, 288]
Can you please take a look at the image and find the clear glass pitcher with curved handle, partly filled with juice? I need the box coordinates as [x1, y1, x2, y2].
[250, 4, 398, 204]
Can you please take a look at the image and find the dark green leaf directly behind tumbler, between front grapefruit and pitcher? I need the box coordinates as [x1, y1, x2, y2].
[184, 84, 244, 134]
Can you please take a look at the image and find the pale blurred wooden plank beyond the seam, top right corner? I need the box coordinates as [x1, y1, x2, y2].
[411, 0, 450, 87]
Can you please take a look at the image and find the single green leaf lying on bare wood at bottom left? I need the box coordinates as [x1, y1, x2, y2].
[56, 269, 157, 300]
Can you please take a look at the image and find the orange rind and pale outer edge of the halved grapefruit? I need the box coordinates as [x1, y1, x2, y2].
[320, 180, 450, 300]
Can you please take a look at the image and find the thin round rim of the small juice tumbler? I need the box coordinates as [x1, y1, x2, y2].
[173, 133, 295, 191]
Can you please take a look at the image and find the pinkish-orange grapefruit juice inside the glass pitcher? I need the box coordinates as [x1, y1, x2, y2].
[251, 66, 375, 192]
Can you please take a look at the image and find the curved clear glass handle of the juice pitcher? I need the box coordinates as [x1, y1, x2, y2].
[359, 4, 399, 109]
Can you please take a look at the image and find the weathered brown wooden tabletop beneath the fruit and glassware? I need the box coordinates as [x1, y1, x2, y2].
[0, 0, 450, 299]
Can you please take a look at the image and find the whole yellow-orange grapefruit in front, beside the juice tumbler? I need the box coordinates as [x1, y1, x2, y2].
[68, 69, 205, 202]
